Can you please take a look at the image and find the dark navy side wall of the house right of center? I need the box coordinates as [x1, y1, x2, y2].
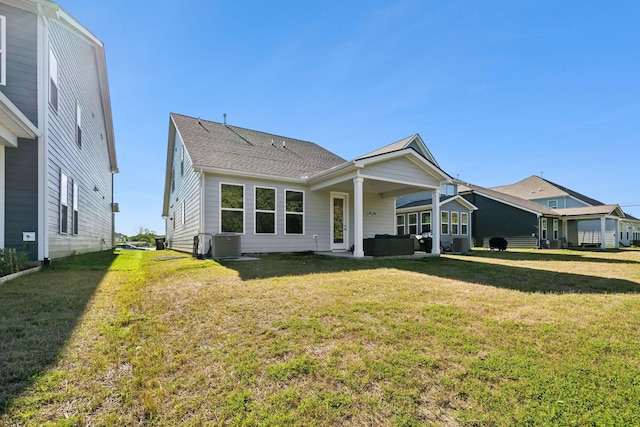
[463, 193, 540, 246]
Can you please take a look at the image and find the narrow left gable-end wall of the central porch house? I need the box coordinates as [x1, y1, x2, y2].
[166, 132, 202, 252]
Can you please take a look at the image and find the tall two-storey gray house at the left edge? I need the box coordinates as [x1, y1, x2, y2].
[0, 0, 117, 260]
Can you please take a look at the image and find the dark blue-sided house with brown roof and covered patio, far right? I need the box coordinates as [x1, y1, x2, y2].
[460, 176, 636, 248]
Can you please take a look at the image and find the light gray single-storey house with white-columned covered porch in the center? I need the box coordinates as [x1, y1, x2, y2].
[162, 114, 453, 257]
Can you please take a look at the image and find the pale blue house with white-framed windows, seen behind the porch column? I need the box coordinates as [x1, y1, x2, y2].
[396, 188, 478, 252]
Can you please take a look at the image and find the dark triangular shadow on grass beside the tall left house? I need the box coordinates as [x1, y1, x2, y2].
[0, 251, 117, 414]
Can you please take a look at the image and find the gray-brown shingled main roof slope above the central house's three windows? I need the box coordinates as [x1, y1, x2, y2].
[169, 113, 346, 179]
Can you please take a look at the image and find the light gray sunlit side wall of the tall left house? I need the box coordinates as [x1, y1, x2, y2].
[45, 19, 113, 258]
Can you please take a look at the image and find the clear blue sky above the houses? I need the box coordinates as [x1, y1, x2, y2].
[59, 0, 640, 235]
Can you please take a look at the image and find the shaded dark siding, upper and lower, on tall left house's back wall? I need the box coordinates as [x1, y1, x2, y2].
[0, 4, 40, 259]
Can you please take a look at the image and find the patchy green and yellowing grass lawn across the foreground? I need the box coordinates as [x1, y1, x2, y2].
[0, 250, 640, 426]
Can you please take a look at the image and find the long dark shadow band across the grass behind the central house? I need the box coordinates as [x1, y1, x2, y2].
[224, 254, 640, 294]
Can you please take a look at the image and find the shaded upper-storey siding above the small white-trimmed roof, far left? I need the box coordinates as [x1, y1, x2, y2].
[0, 4, 38, 126]
